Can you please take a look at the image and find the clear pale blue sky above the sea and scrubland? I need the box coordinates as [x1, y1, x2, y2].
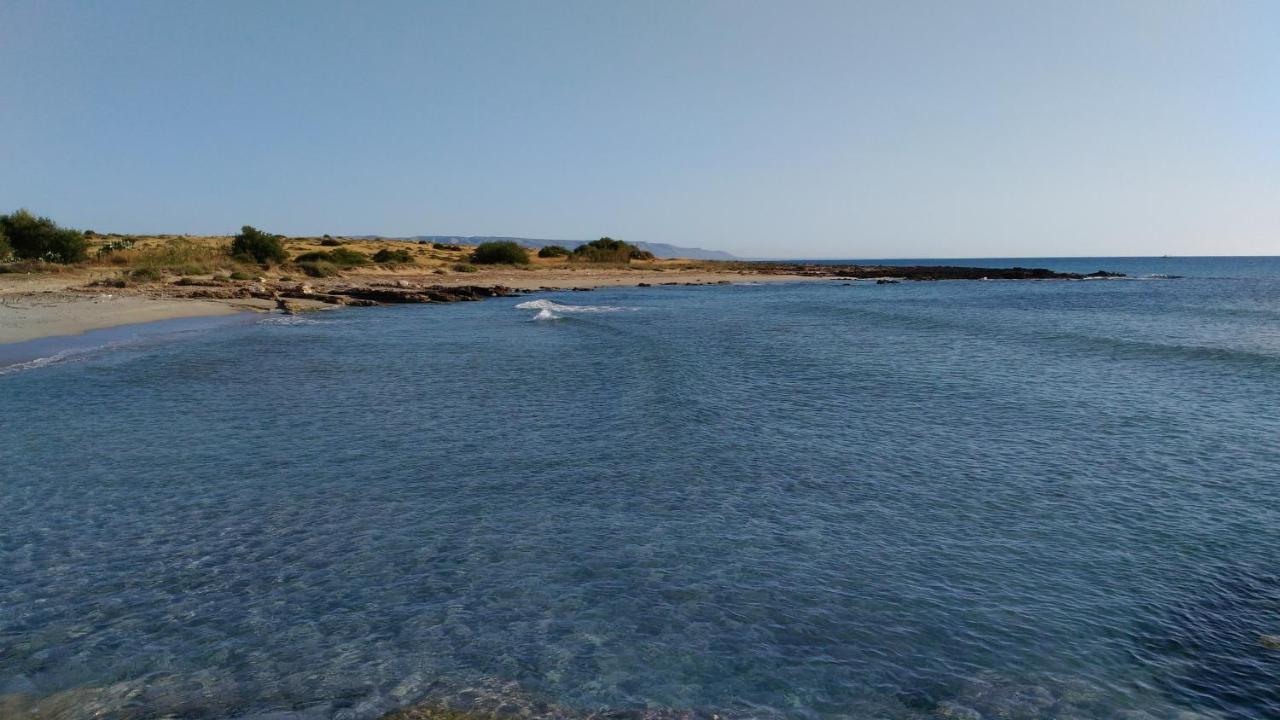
[0, 0, 1280, 258]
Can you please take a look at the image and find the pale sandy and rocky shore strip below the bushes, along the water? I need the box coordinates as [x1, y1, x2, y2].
[0, 254, 1119, 347]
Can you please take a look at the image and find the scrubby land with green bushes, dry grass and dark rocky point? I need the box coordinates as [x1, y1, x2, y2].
[0, 210, 1107, 297]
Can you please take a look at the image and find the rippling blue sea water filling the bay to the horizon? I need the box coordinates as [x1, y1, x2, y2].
[0, 259, 1280, 720]
